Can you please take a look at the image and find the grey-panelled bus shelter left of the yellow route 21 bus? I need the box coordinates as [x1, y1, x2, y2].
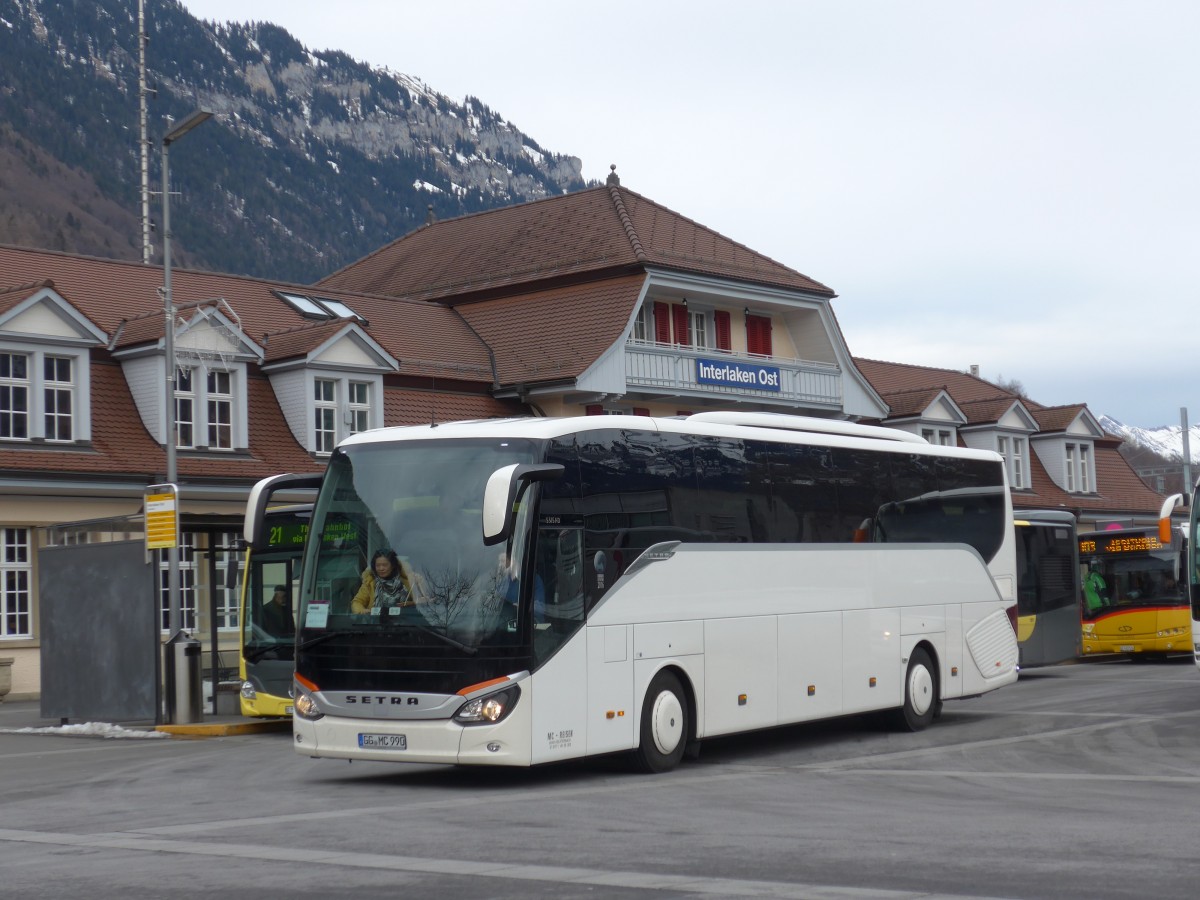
[37, 512, 244, 722]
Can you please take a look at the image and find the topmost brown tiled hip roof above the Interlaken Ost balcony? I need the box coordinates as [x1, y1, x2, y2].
[319, 186, 833, 299]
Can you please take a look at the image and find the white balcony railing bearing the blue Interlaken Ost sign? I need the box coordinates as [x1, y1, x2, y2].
[625, 341, 842, 407]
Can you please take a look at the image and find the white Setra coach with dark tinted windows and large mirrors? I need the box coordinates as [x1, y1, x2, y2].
[246, 413, 1018, 772]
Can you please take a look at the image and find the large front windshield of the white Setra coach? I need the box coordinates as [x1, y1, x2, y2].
[299, 439, 536, 655]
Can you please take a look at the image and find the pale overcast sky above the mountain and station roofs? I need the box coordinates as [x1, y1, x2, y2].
[184, 0, 1200, 427]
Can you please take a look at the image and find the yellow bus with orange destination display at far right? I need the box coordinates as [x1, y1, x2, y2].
[1079, 523, 1192, 658]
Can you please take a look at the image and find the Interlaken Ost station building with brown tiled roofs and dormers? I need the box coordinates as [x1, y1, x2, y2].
[0, 174, 1158, 697]
